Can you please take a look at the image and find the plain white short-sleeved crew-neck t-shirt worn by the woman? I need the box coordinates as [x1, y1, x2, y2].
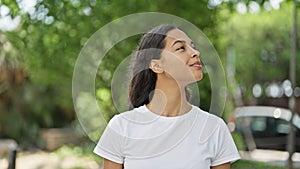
[94, 105, 240, 169]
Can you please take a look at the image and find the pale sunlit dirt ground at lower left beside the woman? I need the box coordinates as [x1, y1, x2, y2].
[0, 151, 101, 169]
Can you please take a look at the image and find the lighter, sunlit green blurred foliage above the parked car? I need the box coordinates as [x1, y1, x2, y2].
[219, 1, 300, 100]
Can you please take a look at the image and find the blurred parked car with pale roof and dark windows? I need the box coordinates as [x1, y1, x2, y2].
[234, 106, 300, 152]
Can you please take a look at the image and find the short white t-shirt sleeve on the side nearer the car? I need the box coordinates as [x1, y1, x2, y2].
[211, 119, 240, 166]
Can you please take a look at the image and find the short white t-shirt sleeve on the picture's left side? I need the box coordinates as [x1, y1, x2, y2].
[94, 116, 124, 164]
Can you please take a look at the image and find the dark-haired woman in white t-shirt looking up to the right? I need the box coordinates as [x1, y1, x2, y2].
[94, 25, 240, 169]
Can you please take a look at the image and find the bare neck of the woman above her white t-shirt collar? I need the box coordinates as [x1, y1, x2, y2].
[147, 78, 191, 116]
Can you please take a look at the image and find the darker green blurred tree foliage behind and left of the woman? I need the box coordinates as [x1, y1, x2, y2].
[0, 0, 218, 145]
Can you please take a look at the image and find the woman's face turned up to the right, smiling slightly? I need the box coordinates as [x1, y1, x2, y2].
[160, 29, 203, 85]
